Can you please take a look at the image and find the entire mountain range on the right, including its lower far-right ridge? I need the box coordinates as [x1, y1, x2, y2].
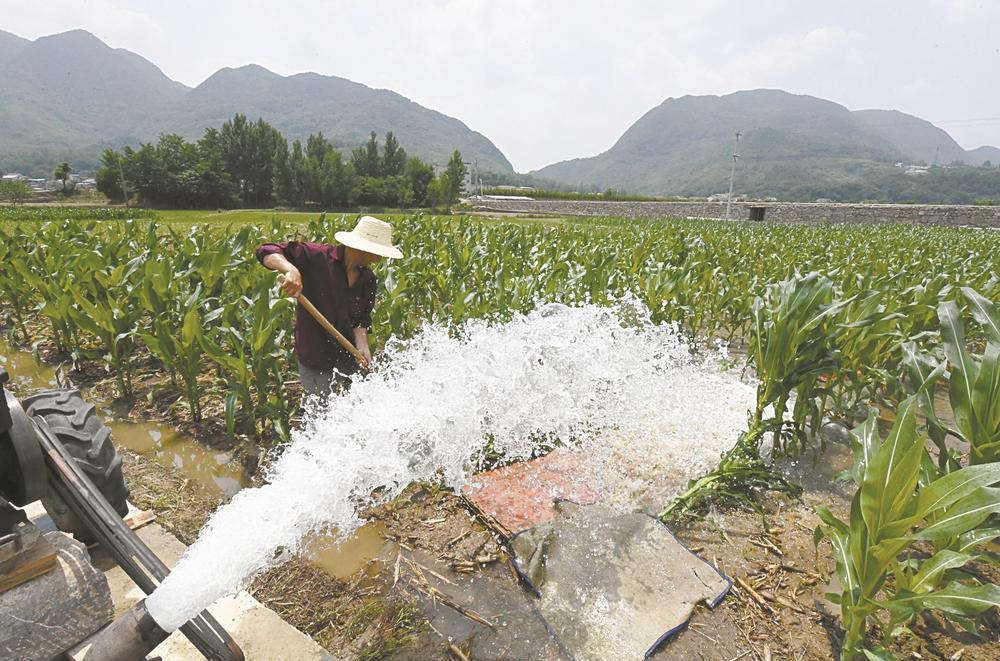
[531, 89, 1000, 201]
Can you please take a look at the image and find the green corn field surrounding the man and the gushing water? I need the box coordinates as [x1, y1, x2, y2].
[0, 214, 1000, 658]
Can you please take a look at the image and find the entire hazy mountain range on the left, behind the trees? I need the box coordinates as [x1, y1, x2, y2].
[0, 30, 513, 174]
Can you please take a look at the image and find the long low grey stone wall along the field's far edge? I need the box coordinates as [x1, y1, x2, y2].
[469, 199, 1000, 228]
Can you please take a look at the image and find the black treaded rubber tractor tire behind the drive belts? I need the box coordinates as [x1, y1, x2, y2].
[22, 388, 128, 542]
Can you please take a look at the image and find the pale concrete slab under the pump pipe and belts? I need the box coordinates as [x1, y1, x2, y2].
[26, 503, 337, 661]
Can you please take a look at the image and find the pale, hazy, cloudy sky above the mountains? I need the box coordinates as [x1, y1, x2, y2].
[0, 0, 1000, 172]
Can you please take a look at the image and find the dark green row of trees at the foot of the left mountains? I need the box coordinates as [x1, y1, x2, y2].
[95, 114, 467, 209]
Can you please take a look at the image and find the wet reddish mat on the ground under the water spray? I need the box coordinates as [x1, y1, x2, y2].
[462, 448, 601, 533]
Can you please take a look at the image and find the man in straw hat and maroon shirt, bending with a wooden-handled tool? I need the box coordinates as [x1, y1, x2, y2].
[257, 216, 403, 403]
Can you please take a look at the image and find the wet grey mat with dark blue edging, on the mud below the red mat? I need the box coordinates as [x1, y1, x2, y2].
[511, 503, 731, 659]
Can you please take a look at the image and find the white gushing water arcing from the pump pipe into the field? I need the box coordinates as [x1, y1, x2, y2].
[147, 301, 753, 631]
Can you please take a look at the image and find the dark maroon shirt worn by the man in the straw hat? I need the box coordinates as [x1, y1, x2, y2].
[257, 241, 378, 374]
